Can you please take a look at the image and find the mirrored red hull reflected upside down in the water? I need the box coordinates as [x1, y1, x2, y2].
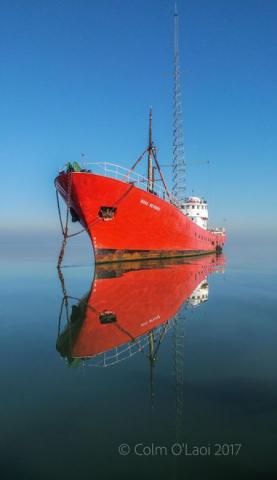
[57, 254, 224, 358]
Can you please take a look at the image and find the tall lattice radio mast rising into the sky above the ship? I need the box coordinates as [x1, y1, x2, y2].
[172, 3, 186, 202]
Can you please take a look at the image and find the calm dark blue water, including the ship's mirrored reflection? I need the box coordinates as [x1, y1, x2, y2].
[0, 240, 277, 480]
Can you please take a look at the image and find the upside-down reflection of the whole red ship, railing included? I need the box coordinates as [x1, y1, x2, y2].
[56, 254, 224, 367]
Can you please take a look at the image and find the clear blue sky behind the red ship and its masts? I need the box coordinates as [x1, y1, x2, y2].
[0, 0, 277, 240]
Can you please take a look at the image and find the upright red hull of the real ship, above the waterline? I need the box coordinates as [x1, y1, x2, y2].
[55, 172, 225, 263]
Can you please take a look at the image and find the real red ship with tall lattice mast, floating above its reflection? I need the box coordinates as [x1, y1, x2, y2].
[55, 7, 225, 264]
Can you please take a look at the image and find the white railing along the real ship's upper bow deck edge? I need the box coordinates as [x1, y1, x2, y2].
[80, 162, 178, 206]
